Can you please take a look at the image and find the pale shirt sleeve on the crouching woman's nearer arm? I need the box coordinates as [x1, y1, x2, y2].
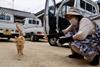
[73, 18, 94, 40]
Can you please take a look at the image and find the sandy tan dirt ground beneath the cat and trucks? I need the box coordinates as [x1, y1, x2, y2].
[0, 40, 100, 67]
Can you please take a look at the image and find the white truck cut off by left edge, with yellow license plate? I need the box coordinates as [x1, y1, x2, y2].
[0, 13, 18, 40]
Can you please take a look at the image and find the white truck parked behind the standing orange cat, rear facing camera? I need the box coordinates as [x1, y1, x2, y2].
[21, 18, 44, 41]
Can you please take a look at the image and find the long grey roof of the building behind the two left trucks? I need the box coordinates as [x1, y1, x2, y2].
[0, 7, 37, 22]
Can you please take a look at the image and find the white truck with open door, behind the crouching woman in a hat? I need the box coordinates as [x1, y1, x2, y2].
[44, 0, 99, 46]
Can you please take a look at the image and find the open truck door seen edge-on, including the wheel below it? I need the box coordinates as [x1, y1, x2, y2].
[44, 0, 57, 46]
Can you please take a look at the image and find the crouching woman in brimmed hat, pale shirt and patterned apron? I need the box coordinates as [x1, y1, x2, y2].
[57, 8, 100, 65]
